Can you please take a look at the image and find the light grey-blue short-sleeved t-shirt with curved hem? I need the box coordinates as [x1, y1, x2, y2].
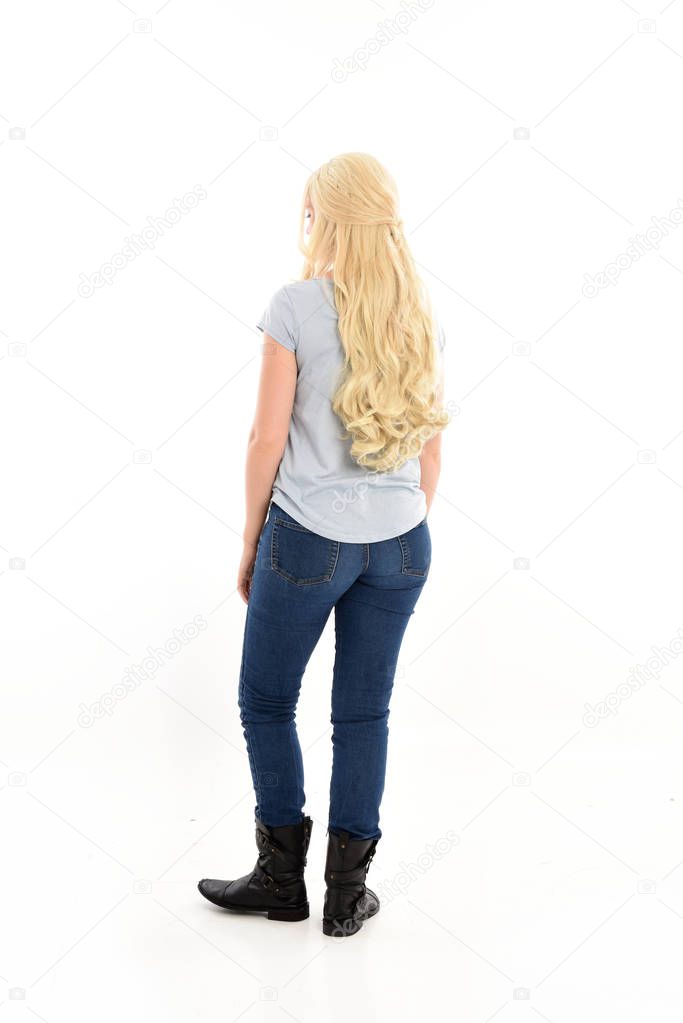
[257, 277, 445, 543]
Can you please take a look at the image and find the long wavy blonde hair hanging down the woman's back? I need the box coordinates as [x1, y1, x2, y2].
[299, 152, 449, 473]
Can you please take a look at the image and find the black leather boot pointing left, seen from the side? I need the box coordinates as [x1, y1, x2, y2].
[197, 817, 313, 920]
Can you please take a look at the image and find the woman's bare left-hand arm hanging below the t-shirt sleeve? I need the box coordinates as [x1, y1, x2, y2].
[237, 333, 297, 603]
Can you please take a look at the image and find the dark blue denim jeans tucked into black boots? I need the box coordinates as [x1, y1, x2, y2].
[238, 502, 431, 839]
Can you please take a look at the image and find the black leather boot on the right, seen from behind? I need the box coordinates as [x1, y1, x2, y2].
[322, 831, 379, 938]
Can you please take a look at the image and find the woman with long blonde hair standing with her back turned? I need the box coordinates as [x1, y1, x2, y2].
[199, 152, 448, 936]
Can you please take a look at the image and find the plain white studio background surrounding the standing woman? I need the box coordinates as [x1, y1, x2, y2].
[0, 0, 683, 1023]
